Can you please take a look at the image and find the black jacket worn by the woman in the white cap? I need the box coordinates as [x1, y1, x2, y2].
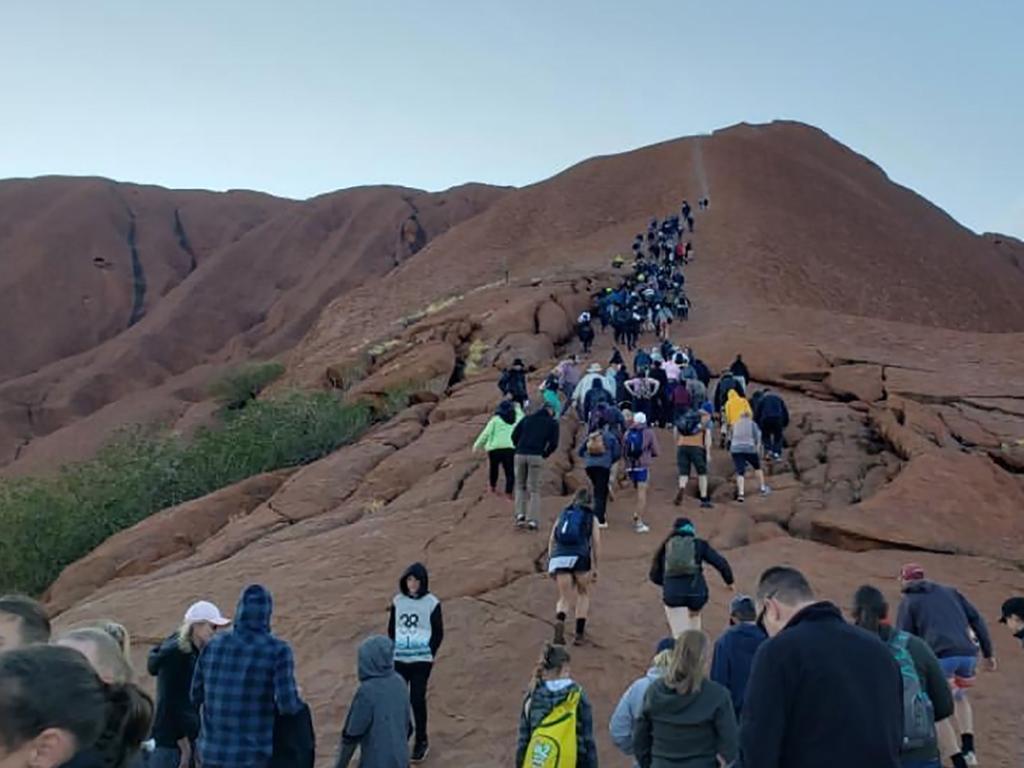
[146, 633, 199, 748]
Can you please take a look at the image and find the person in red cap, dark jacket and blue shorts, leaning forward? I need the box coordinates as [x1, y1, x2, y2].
[896, 563, 997, 765]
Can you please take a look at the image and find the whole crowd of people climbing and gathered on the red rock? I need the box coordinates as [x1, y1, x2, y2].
[0, 198, 1024, 768]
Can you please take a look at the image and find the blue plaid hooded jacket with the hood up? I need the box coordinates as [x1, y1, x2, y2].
[191, 586, 303, 768]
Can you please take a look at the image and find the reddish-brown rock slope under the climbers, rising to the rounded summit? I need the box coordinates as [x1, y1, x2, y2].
[12, 124, 1024, 768]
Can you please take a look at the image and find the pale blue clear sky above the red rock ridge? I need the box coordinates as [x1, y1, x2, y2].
[0, 0, 1024, 238]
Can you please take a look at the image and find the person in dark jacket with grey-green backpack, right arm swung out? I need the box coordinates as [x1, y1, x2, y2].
[649, 517, 735, 637]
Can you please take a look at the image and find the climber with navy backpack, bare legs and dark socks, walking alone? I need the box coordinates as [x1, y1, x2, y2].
[548, 488, 601, 645]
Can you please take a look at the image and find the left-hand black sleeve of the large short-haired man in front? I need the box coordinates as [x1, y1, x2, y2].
[739, 641, 792, 768]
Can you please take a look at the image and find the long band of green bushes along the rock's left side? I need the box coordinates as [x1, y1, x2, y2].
[0, 392, 409, 594]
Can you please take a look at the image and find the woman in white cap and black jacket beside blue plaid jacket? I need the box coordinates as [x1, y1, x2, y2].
[146, 600, 230, 768]
